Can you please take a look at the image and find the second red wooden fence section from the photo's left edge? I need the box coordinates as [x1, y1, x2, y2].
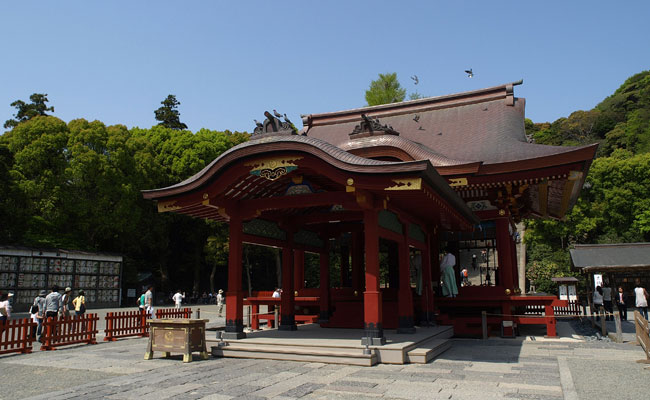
[41, 314, 99, 350]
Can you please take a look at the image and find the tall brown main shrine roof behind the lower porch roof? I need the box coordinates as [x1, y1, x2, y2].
[304, 82, 596, 173]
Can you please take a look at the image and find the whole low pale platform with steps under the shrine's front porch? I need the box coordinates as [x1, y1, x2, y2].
[206, 324, 454, 366]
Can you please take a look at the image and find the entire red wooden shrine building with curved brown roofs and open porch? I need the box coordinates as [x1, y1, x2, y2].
[144, 82, 597, 344]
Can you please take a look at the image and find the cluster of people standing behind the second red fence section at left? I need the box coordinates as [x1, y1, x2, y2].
[29, 285, 86, 341]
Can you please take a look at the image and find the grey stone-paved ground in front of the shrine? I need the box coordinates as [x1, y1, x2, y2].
[0, 323, 650, 400]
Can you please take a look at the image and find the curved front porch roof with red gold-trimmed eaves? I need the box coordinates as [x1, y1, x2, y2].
[143, 135, 478, 231]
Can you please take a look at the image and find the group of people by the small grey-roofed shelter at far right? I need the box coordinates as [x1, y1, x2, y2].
[592, 279, 650, 321]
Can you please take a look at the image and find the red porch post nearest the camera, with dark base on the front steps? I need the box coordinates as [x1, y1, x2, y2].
[362, 209, 386, 346]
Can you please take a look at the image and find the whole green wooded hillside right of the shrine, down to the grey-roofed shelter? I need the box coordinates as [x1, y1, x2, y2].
[525, 71, 650, 292]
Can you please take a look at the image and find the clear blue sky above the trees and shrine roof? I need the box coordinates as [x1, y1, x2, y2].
[0, 0, 650, 132]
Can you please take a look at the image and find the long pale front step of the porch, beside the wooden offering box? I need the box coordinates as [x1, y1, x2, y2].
[212, 344, 377, 367]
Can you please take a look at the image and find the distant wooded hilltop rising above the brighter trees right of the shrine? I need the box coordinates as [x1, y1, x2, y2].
[526, 71, 650, 156]
